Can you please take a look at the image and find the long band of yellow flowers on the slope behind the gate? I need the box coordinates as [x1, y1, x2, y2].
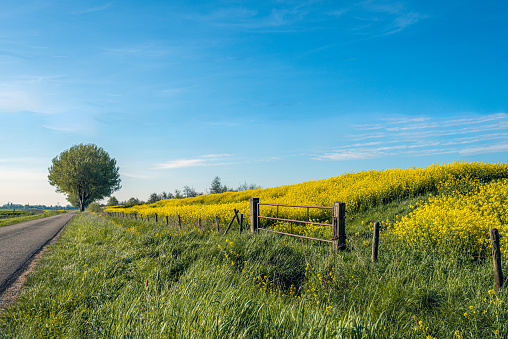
[105, 162, 508, 242]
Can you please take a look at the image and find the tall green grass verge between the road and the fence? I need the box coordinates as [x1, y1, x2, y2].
[0, 199, 508, 338]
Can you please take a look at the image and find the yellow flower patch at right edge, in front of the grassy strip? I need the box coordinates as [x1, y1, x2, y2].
[392, 179, 508, 253]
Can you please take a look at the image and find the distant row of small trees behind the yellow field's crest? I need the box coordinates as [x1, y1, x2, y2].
[107, 177, 262, 206]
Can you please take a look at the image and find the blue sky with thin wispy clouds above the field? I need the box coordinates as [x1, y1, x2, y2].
[0, 0, 508, 205]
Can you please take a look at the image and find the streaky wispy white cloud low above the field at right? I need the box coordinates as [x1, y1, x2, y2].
[314, 113, 508, 161]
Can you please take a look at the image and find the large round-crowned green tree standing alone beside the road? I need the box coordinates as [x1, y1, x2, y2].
[48, 144, 121, 211]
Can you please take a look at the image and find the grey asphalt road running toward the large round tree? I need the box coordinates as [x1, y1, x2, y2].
[0, 211, 76, 293]
